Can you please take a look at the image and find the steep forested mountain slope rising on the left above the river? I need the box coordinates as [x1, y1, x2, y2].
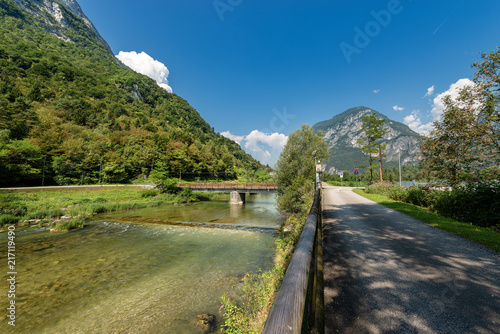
[0, 0, 265, 186]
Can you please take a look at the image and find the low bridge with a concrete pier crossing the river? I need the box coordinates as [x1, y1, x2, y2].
[178, 182, 278, 204]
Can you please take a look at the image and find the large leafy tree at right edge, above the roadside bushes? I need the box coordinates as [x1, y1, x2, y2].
[420, 48, 500, 186]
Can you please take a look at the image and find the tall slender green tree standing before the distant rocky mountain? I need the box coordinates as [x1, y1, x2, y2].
[358, 113, 389, 183]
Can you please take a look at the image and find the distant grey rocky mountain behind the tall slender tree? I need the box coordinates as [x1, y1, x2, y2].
[313, 107, 421, 174]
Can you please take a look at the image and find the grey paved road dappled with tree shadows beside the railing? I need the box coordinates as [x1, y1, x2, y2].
[323, 186, 500, 334]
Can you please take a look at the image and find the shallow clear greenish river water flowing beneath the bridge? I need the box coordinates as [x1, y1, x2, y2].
[0, 195, 279, 333]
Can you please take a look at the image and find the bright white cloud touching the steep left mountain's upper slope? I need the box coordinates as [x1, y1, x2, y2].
[116, 51, 172, 93]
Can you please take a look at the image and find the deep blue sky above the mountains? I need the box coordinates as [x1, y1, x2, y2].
[78, 0, 500, 165]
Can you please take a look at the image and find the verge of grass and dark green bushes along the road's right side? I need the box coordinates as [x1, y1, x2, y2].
[355, 183, 500, 252]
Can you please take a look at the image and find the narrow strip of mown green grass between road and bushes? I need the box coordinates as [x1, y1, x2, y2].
[354, 189, 500, 252]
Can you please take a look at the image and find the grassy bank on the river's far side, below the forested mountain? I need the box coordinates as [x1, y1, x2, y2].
[0, 186, 227, 231]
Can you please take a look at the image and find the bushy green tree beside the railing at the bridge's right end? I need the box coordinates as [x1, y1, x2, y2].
[276, 124, 329, 213]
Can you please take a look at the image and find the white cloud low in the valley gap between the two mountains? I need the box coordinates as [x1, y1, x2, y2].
[221, 130, 288, 166]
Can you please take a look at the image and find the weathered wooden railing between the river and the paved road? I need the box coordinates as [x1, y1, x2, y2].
[262, 189, 324, 334]
